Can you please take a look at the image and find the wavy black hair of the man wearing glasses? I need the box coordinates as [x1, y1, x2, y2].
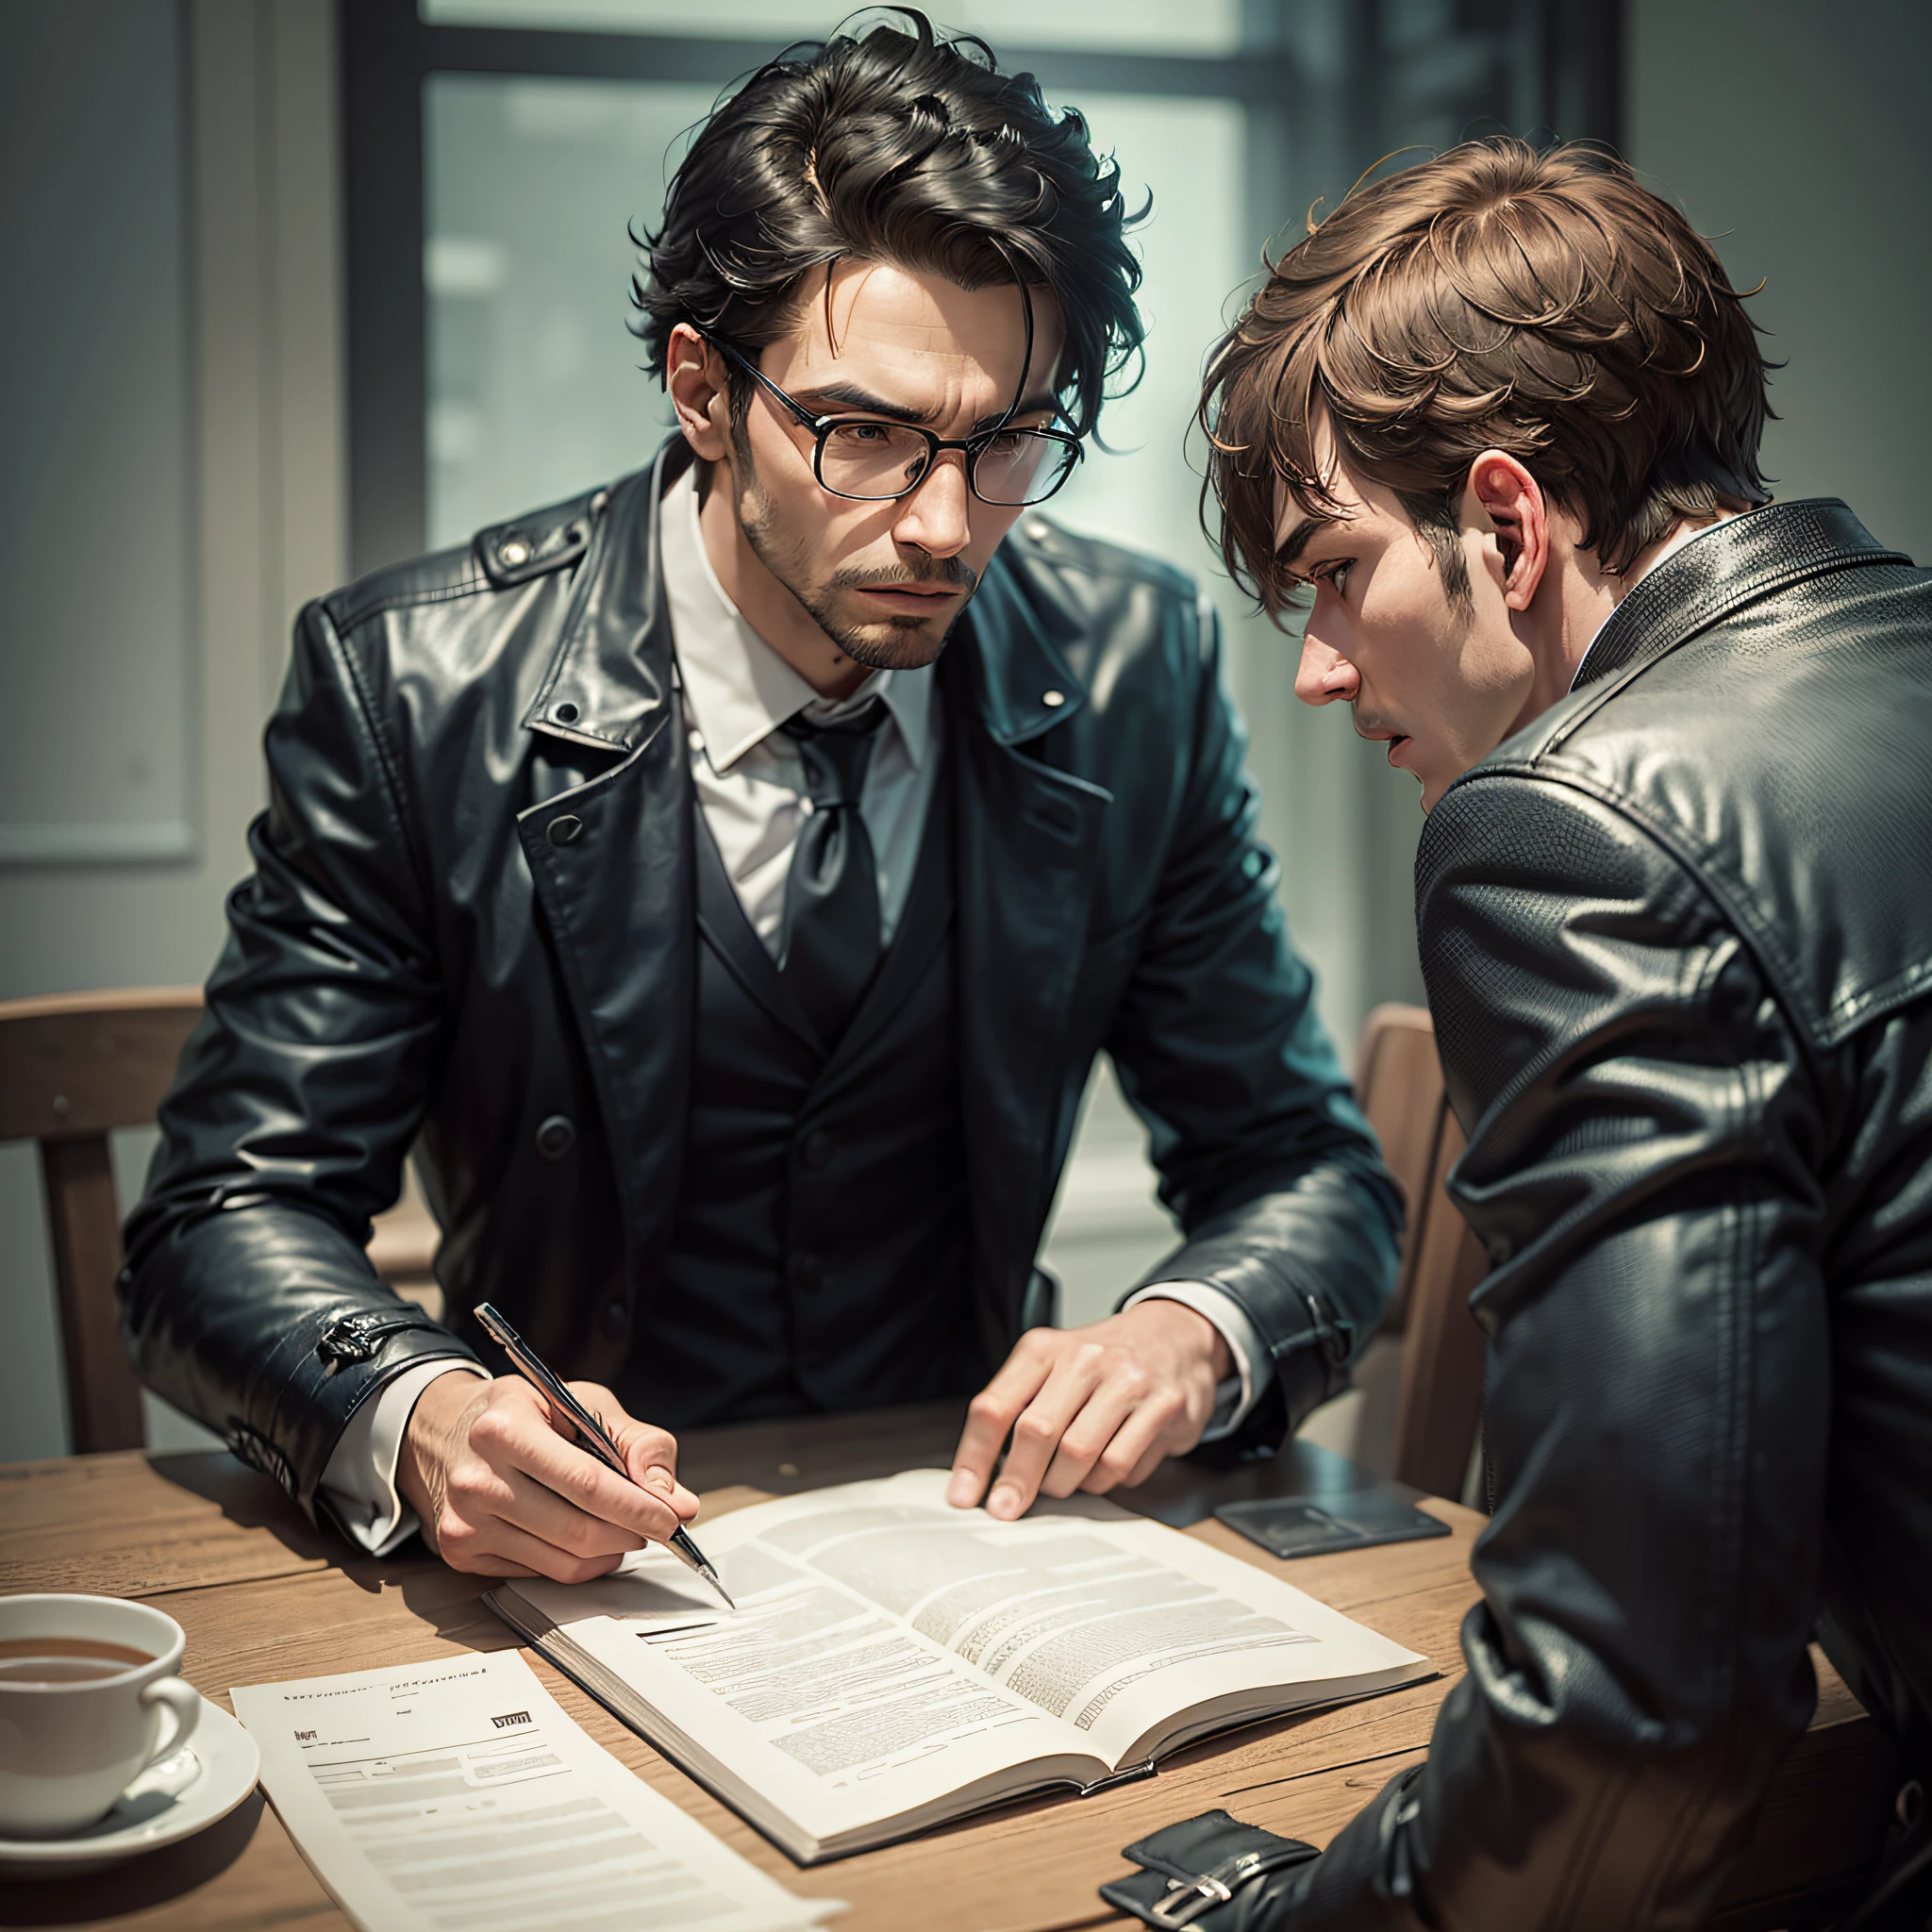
[630, 8, 1148, 433]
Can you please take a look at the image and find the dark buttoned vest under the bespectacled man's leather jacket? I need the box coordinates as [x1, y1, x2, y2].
[616, 761, 985, 1430]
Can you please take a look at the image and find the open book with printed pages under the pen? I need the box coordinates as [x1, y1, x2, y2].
[485, 1468, 1432, 1864]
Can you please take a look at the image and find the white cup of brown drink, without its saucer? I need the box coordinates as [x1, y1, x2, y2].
[0, 1596, 201, 1838]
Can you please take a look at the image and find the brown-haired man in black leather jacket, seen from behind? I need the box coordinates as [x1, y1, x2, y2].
[1112, 142, 1932, 1932]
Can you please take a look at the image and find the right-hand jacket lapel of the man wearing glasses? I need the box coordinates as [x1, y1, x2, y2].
[941, 566, 1113, 1362]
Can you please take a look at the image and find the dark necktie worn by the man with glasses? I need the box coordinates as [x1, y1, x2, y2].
[778, 699, 885, 1049]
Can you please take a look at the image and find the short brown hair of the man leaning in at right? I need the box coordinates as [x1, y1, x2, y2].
[1200, 139, 1772, 614]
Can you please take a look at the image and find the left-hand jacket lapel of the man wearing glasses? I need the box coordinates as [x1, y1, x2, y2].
[518, 439, 697, 1294]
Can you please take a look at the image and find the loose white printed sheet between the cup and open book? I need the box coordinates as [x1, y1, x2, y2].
[230, 1650, 842, 1932]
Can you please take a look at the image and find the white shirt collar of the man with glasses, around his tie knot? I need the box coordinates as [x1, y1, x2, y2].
[660, 470, 933, 773]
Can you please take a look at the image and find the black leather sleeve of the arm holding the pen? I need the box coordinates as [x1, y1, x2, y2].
[122, 605, 472, 1515]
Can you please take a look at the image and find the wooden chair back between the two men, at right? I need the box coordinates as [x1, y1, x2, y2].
[1357, 1007, 1490, 1499]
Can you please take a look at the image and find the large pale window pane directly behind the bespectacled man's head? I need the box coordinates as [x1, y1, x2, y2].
[424, 75, 1254, 572]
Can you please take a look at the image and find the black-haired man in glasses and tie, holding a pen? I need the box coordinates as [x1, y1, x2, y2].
[125, 13, 1399, 1580]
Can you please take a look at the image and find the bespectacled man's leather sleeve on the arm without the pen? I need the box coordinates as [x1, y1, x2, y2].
[1108, 612, 1403, 1458]
